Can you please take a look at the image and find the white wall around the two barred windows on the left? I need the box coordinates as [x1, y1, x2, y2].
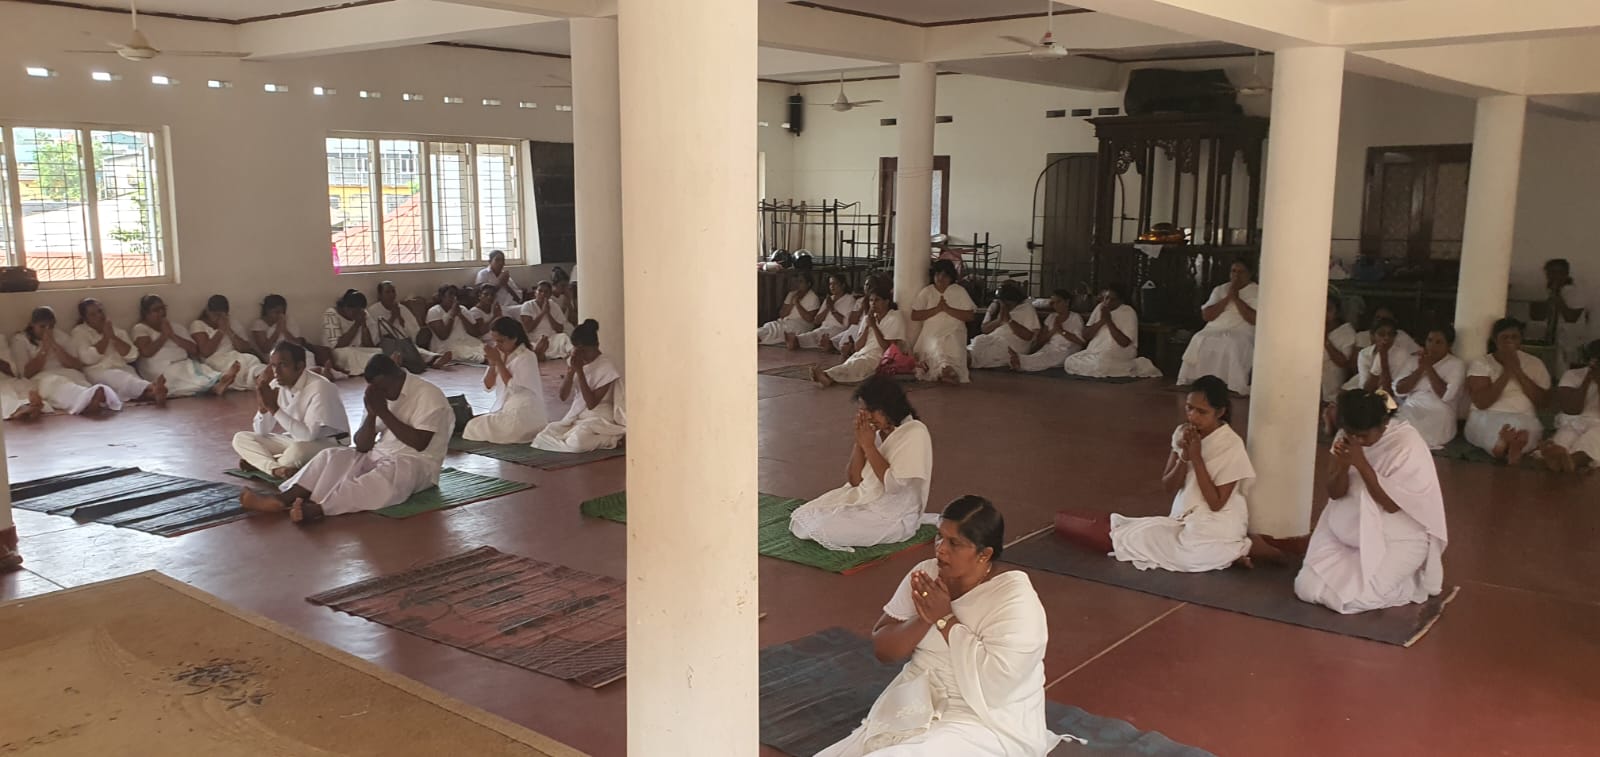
[0, 3, 571, 331]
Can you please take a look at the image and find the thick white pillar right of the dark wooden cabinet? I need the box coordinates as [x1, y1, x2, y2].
[1250, 48, 1344, 536]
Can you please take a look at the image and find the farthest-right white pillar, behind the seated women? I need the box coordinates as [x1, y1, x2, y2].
[1456, 94, 1528, 362]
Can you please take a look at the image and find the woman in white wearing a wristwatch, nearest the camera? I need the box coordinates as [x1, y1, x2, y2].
[816, 496, 1061, 757]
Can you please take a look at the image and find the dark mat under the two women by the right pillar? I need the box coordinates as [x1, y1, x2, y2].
[1005, 531, 1458, 647]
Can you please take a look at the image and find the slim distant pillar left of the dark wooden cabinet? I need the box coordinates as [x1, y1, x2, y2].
[894, 62, 939, 307]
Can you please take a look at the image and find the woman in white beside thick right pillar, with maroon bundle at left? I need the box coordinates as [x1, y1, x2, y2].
[1056, 376, 1256, 573]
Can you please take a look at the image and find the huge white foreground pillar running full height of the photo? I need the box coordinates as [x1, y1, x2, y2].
[617, 0, 760, 755]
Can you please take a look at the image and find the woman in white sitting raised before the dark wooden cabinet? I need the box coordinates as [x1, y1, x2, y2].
[1178, 259, 1261, 395]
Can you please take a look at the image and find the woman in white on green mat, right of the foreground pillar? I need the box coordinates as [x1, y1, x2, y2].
[789, 376, 933, 552]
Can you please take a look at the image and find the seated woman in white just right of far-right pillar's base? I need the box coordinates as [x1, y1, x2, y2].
[1464, 318, 1550, 466]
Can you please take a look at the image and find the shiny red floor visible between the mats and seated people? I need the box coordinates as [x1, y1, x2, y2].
[0, 349, 1600, 757]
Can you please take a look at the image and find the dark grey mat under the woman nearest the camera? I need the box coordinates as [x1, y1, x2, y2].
[762, 627, 1211, 757]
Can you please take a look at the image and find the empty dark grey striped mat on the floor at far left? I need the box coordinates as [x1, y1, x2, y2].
[11, 467, 248, 536]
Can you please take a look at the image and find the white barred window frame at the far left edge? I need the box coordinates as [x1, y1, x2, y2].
[0, 118, 178, 291]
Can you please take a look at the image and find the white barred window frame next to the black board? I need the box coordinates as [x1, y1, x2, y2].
[323, 130, 538, 274]
